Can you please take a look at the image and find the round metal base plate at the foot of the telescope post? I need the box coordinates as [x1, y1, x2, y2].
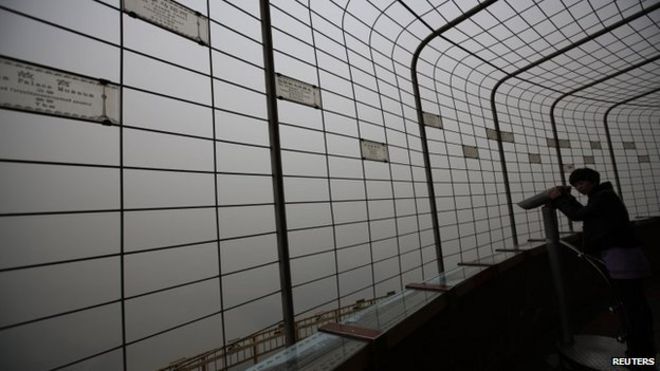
[558, 335, 628, 371]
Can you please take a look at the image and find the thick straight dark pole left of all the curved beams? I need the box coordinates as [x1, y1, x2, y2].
[259, 0, 296, 345]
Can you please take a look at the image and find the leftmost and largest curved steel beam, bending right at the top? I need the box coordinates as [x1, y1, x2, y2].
[410, 0, 497, 272]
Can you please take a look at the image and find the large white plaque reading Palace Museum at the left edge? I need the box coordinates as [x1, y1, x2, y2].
[0, 57, 119, 124]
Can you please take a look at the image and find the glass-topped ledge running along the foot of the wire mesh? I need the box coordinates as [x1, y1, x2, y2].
[248, 242, 556, 371]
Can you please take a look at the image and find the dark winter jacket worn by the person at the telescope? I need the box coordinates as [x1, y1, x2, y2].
[553, 182, 639, 253]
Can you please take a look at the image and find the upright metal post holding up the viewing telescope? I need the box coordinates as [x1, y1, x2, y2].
[542, 206, 573, 345]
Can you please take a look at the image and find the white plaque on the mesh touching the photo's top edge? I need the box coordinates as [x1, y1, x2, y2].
[123, 0, 209, 45]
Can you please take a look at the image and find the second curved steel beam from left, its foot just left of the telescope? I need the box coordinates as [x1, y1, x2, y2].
[490, 2, 660, 245]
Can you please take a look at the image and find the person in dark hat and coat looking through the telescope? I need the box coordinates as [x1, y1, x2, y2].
[548, 168, 656, 357]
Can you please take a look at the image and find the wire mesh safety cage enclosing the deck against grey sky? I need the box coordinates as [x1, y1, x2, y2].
[0, 0, 660, 369]
